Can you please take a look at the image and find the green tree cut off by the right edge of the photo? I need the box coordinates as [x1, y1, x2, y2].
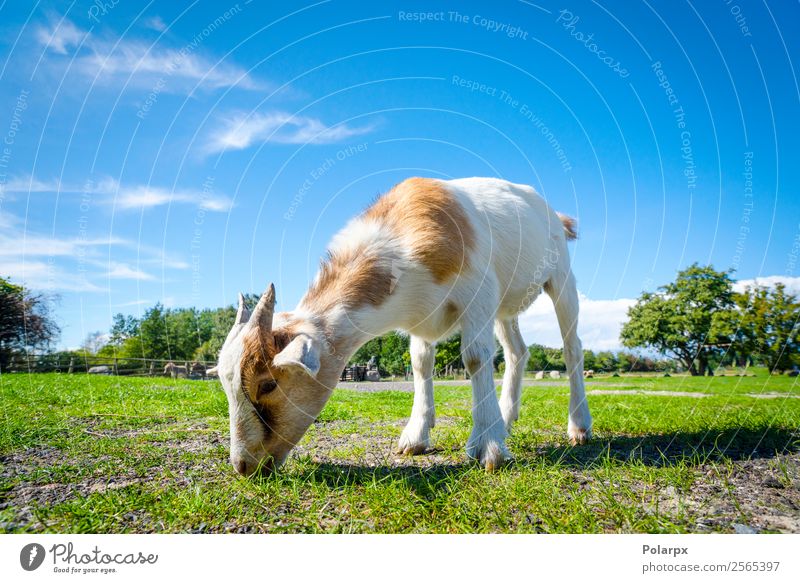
[735, 283, 800, 372]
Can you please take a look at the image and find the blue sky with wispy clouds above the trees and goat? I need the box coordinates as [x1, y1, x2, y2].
[0, 0, 800, 348]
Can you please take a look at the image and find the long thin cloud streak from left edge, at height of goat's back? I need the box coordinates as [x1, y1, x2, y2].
[5, 176, 233, 217]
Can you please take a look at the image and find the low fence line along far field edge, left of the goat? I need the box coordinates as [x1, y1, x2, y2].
[0, 353, 216, 378]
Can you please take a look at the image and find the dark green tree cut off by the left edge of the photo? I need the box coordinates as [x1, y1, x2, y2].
[0, 277, 60, 370]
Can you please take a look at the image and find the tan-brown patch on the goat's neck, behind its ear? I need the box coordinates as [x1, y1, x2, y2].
[303, 250, 391, 312]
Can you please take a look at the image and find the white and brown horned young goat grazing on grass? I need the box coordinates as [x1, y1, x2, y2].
[217, 178, 592, 475]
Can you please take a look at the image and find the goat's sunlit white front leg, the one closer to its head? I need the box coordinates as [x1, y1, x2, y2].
[397, 336, 436, 455]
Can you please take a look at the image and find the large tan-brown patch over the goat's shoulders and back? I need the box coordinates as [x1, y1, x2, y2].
[364, 178, 475, 283]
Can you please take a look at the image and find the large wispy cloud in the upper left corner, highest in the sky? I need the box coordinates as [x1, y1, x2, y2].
[35, 17, 265, 93]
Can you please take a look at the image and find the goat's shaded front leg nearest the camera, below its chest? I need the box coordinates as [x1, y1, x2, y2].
[461, 320, 511, 471]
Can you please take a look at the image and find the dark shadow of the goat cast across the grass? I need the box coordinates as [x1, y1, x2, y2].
[290, 427, 800, 496]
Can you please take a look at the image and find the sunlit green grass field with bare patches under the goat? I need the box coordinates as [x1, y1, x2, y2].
[0, 374, 800, 533]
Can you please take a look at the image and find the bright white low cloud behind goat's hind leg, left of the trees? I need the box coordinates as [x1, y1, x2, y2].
[519, 293, 636, 351]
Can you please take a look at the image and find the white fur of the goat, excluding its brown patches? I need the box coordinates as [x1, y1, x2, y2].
[220, 178, 591, 468]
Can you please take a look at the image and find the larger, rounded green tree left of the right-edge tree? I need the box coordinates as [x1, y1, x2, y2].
[620, 263, 734, 375]
